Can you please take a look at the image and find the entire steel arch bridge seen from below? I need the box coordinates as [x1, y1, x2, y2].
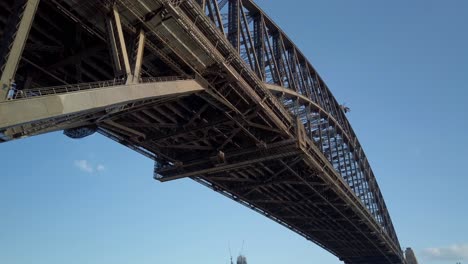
[0, 0, 406, 264]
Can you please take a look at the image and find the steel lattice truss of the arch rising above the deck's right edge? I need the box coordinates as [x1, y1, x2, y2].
[195, 0, 396, 239]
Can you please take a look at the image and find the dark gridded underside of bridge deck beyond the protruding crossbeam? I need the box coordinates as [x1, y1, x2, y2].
[156, 136, 398, 263]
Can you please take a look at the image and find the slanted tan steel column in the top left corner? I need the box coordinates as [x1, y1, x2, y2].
[0, 0, 39, 101]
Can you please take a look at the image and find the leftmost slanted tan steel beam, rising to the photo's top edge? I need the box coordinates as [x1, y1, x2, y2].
[0, 0, 39, 101]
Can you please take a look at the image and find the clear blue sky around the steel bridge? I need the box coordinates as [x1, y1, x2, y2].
[0, 0, 468, 264]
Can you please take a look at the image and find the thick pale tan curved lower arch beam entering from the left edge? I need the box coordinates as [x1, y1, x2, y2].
[0, 80, 204, 132]
